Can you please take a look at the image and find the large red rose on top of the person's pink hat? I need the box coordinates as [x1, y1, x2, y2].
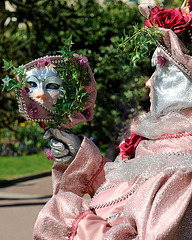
[145, 6, 192, 33]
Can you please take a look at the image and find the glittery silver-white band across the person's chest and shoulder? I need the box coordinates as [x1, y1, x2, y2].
[105, 152, 192, 184]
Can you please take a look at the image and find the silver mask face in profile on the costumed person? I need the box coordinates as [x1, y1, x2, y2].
[150, 51, 192, 116]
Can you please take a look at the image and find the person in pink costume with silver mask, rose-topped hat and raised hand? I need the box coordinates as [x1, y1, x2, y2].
[33, 4, 192, 240]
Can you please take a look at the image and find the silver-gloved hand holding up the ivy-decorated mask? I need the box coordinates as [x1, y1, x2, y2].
[43, 128, 81, 164]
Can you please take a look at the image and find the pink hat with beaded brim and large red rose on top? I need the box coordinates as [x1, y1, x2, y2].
[139, 0, 192, 77]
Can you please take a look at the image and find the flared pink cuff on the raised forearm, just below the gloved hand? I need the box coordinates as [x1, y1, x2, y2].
[52, 137, 109, 196]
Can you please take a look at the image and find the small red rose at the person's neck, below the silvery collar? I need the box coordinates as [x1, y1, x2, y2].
[119, 133, 146, 159]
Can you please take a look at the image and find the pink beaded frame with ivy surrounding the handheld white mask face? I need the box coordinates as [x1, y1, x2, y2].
[3, 39, 97, 129]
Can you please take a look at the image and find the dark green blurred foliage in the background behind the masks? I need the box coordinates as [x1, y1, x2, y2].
[0, 0, 154, 158]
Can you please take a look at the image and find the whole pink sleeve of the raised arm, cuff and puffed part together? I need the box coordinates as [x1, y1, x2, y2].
[34, 138, 110, 240]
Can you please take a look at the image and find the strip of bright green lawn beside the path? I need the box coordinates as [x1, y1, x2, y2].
[0, 153, 53, 180]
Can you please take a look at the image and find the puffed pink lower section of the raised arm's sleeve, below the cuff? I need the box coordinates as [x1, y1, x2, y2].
[33, 192, 110, 240]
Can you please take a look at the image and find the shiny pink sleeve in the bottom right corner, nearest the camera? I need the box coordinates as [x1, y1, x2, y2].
[104, 171, 192, 240]
